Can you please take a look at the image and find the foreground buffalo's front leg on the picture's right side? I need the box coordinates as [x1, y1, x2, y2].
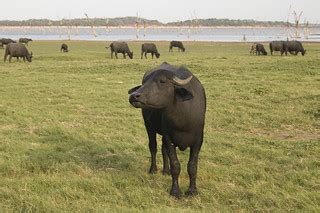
[187, 142, 202, 196]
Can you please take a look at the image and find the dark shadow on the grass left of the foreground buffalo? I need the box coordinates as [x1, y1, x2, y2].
[23, 128, 135, 174]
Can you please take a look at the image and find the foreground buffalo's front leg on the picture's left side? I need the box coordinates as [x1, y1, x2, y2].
[165, 137, 181, 198]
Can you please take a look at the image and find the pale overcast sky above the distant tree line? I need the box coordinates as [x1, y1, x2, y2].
[0, 0, 320, 24]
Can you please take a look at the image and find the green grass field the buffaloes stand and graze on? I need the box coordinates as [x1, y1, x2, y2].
[0, 41, 320, 212]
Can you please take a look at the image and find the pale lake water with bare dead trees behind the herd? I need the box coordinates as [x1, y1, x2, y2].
[0, 27, 320, 42]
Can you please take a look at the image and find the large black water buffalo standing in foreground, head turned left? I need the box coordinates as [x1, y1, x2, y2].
[128, 63, 206, 197]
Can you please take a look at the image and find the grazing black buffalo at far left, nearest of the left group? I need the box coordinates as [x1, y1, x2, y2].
[4, 43, 32, 62]
